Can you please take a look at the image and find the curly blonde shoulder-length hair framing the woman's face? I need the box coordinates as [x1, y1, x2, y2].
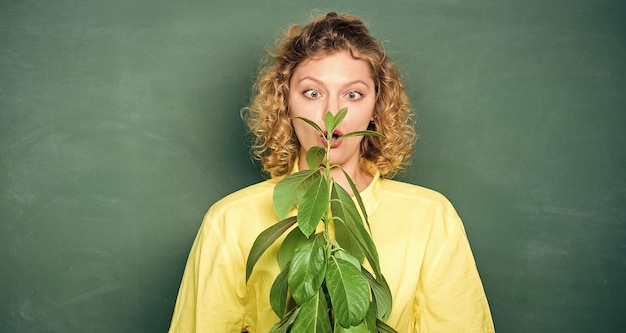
[242, 13, 417, 177]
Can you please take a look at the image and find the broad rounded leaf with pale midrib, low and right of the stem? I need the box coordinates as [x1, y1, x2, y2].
[326, 257, 370, 327]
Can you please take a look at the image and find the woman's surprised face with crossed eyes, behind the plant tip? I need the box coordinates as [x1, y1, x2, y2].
[289, 51, 376, 168]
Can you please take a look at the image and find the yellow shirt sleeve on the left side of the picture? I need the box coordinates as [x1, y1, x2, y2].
[169, 210, 245, 333]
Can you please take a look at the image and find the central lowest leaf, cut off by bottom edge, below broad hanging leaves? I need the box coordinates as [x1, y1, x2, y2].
[291, 290, 332, 333]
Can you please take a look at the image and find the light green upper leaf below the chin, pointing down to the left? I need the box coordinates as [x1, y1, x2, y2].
[273, 170, 322, 219]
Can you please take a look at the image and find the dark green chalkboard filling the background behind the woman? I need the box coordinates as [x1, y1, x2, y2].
[0, 0, 626, 333]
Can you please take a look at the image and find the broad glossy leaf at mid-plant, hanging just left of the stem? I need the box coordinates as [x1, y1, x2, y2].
[288, 234, 326, 305]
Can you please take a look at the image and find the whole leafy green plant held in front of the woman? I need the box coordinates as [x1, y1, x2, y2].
[246, 108, 395, 333]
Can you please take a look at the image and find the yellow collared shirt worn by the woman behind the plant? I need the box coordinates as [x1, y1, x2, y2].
[169, 176, 494, 333]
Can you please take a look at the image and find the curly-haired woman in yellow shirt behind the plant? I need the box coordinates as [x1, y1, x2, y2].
[170, 13, 494, 333]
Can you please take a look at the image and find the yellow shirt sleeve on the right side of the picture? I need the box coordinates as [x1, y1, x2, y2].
[415, 203, 495, 333]
